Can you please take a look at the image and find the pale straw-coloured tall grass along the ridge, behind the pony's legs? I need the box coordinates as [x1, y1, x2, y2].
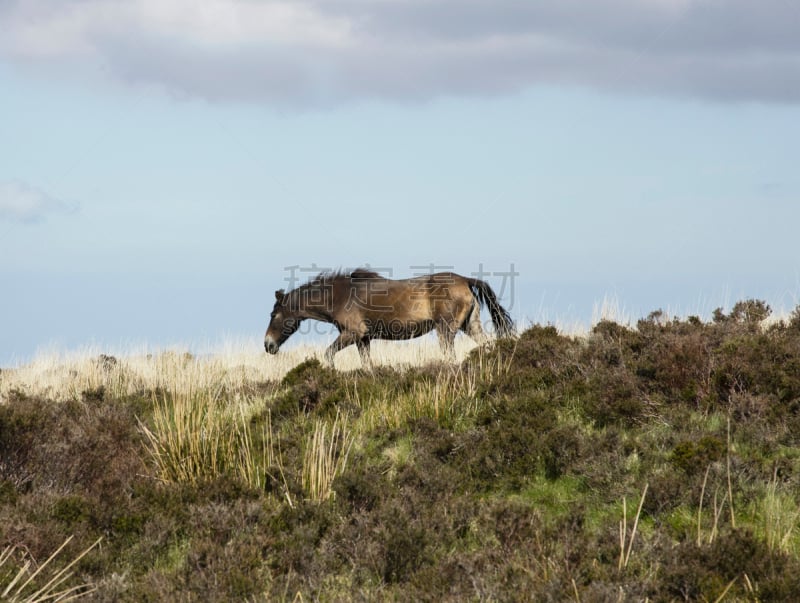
[0, 336, 482, 402]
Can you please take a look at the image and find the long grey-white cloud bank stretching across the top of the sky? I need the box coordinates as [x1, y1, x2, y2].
[0, 0, 800, 105]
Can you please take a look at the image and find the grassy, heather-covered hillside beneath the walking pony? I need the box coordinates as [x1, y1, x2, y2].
[0, 301, 800, 602]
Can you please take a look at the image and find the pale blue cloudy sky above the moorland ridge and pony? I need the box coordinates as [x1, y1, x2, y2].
[0, 0, 800, 367]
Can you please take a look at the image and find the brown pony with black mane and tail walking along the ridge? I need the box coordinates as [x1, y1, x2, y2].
[264, 268, 514, 366]
